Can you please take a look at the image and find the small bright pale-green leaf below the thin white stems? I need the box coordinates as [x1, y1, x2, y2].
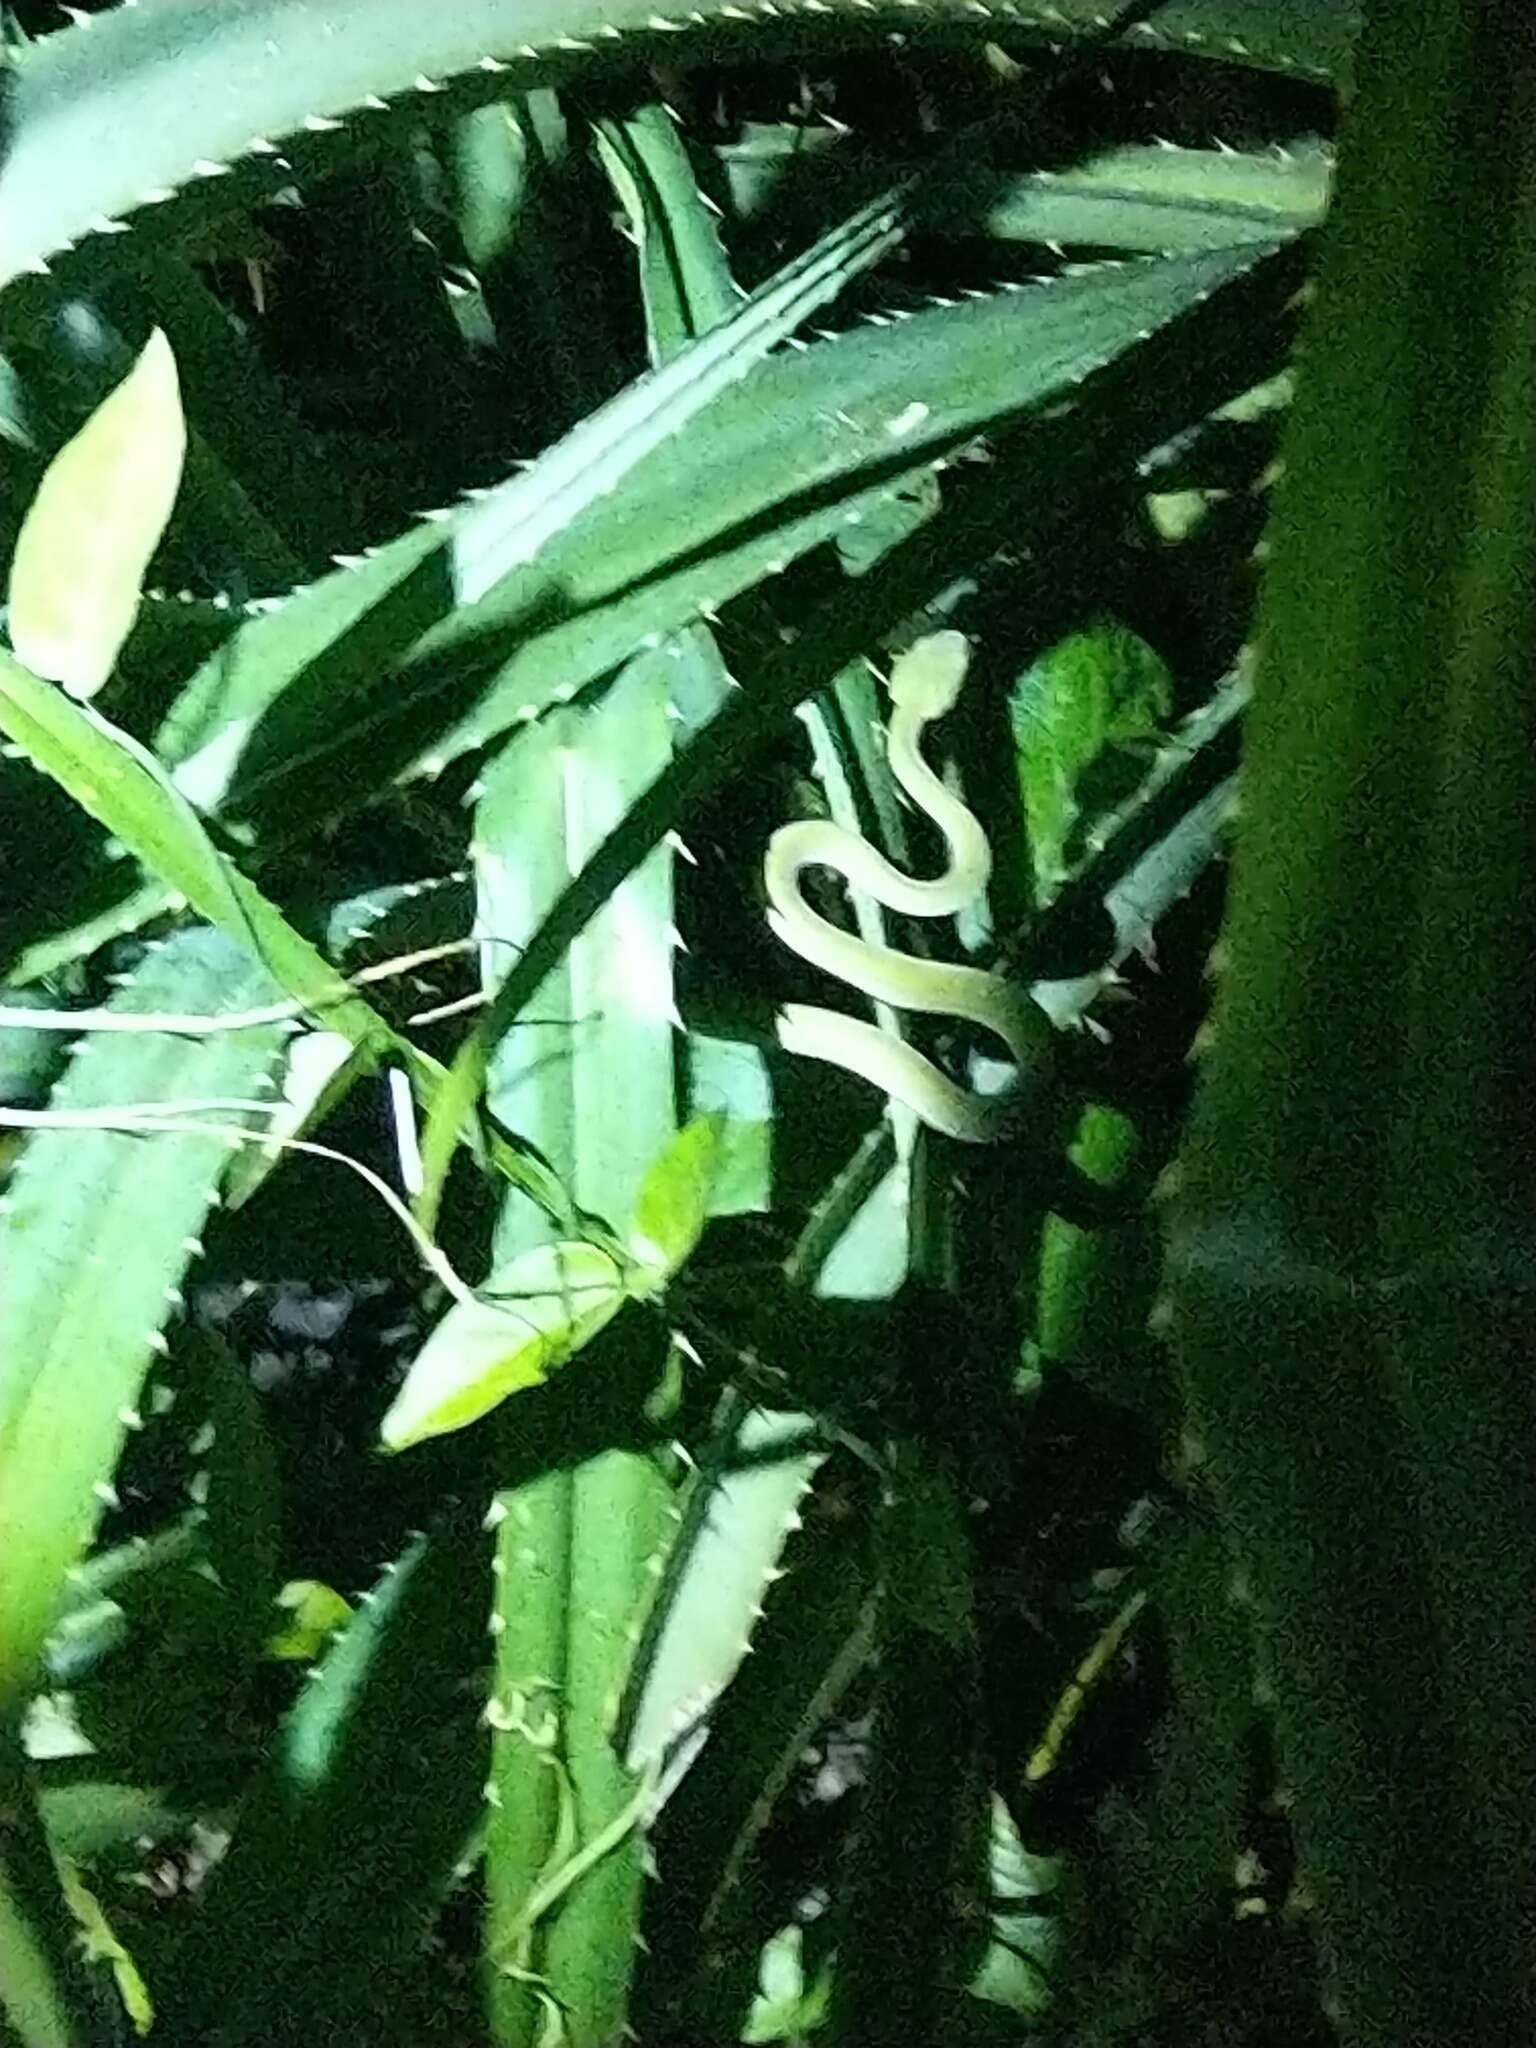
[381, 1241, 629, 1450]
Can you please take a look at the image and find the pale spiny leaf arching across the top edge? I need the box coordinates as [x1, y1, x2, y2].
[0, 0, 1358, 283]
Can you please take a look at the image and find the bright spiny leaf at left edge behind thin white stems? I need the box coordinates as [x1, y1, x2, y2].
[0, 930, 281, 1704]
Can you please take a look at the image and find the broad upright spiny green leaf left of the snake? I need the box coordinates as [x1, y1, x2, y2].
[467, 626, 678, 2048]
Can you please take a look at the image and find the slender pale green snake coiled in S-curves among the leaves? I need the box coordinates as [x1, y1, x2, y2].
[762, 631, 1053, 1145]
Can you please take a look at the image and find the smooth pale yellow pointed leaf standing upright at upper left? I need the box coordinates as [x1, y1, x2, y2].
[10, 328, 186, 698]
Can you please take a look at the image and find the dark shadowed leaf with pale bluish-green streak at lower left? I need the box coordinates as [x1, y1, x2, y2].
[156, 1505, 489, 2048]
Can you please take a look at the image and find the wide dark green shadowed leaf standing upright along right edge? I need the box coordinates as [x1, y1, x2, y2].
[1169, 0, 1536, 2048]
